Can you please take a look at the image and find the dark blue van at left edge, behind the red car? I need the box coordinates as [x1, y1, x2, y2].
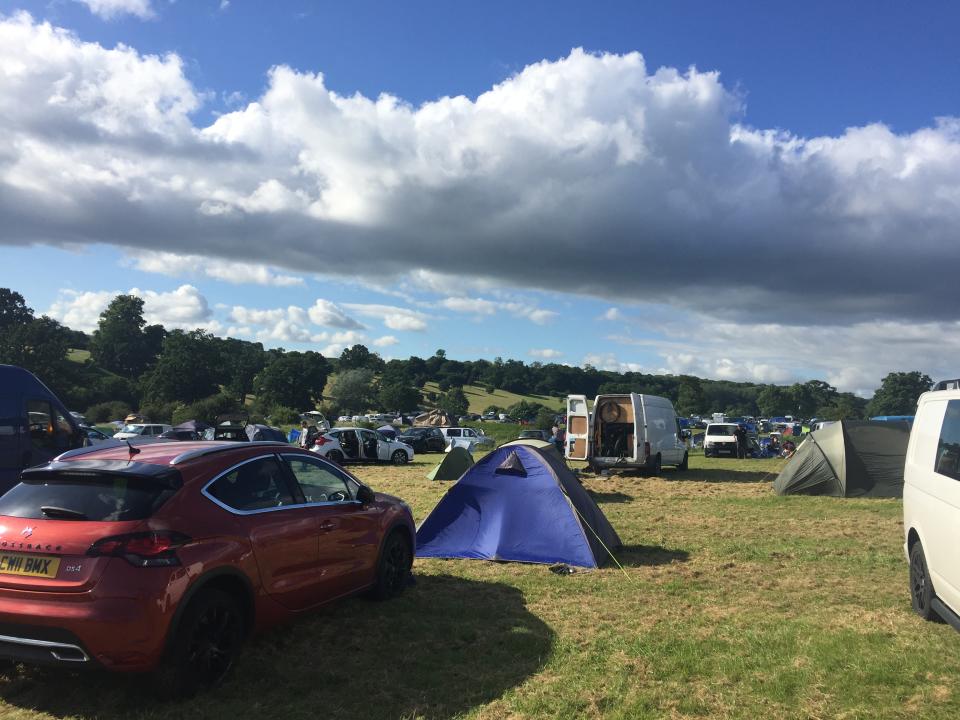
[0, 365, 85, 494]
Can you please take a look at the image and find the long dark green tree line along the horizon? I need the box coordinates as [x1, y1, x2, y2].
[0, 288, 931, 424]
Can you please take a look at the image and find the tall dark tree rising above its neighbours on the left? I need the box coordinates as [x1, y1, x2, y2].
[90, 295, 163, 377]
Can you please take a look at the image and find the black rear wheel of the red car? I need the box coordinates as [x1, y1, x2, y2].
[157, 588, 246, 699]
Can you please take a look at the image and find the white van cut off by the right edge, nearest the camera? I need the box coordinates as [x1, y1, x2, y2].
[903, 380, 960, 630]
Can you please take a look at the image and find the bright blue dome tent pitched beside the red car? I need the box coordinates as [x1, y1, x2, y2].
[417, 445, 621, 567]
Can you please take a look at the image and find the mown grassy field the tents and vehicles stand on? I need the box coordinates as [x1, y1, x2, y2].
[0, 455, 960, 720]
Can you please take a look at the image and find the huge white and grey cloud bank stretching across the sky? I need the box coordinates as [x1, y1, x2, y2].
[0, 11, 960, 358]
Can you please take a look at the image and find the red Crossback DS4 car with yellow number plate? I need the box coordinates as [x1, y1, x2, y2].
[0, 442, 416, 695]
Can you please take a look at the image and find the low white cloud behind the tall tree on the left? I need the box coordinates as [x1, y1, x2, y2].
[47, 285, 210, 332]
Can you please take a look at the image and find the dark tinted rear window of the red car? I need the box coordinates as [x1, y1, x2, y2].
[0, 473, 176, 521]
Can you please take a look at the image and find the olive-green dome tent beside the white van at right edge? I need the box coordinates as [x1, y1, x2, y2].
[773, 420, 910, 497]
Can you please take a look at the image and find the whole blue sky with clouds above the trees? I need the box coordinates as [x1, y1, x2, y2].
[0, 0, 960, 396]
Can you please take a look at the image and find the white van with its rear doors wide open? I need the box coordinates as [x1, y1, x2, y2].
[564, 393, 688, 475]
